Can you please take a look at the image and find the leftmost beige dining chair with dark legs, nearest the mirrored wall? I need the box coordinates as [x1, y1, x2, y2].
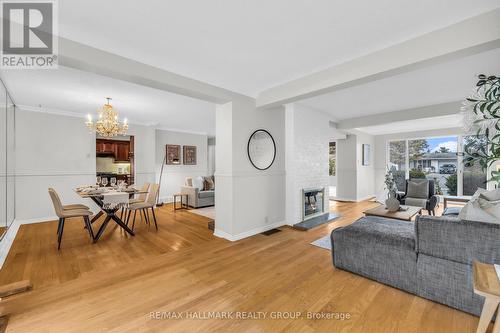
[49, 188, 94, 250]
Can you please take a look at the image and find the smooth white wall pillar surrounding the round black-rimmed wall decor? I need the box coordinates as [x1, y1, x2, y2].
[215, 99, 285, 240]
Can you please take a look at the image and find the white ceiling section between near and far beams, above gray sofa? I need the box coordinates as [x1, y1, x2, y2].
[300, 49, 500, 120]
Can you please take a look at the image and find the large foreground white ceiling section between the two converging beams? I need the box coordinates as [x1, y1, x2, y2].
[59, 0, 500, 96]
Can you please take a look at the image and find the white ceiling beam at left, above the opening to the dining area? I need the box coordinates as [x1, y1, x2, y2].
[58, 37, 254, 104]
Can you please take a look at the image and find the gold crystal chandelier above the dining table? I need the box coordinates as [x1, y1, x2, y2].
[85, 97, 128, 137]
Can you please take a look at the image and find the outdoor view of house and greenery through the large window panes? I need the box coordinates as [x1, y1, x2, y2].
[388, 136, 486, 195]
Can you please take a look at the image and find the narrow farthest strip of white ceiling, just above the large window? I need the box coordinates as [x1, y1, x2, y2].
[356, 114, 463, 135]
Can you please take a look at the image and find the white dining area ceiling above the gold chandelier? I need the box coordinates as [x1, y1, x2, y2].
[2, 66, 215, 135]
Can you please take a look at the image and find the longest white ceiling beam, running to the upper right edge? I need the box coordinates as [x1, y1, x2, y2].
[257, 8, 500, 108]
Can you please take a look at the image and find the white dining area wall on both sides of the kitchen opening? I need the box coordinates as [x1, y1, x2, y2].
[16, 108, 154, 222]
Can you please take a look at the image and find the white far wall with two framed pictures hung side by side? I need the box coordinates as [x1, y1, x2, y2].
[155, 130, 209, 202]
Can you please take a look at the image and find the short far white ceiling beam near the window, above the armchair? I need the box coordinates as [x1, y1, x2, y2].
[337, 101, 462, 130]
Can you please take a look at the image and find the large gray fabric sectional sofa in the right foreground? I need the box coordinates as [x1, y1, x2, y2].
[331, 216, 500, 315]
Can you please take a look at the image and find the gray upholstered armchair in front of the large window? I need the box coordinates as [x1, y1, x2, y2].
[399, 178, 439, 215]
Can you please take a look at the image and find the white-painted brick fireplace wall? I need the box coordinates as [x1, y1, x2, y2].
[285, 104, 331, 225]
